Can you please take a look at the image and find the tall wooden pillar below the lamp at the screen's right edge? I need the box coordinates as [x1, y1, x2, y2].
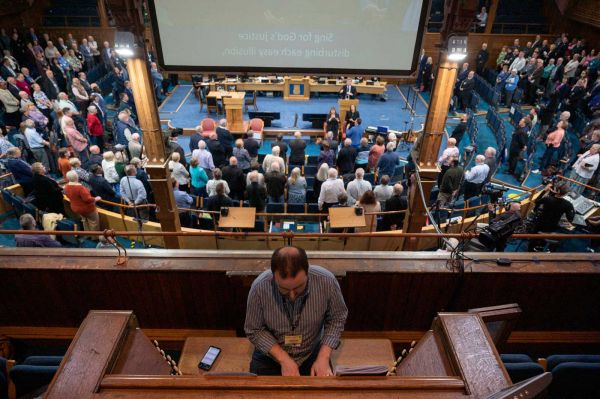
[402, 53, 458, 251]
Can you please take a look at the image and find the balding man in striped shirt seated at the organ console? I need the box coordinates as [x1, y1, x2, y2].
[244, 247, 348, 376]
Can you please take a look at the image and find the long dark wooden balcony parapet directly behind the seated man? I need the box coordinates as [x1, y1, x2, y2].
[0, 248, 600, 341]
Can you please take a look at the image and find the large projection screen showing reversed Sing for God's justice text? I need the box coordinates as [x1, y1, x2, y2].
[149, 0, 429, 75]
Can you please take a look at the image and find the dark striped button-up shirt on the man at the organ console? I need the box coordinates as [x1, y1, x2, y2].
[244, 266, 348, 365]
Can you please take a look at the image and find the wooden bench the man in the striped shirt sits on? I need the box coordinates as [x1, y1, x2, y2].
[179, 337, 395, 375]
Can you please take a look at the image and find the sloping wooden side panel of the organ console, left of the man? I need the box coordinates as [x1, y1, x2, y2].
[46, 311, 134, 399]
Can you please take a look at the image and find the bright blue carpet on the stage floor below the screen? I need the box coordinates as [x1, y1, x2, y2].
[160, 85, 426, 130]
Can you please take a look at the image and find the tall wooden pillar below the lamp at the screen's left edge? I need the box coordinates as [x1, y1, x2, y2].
[127, 49, 181, 249]
